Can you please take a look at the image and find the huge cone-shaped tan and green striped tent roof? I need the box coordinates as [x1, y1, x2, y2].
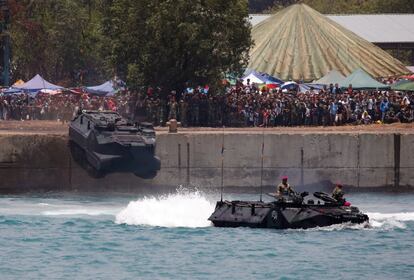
[249, 4, 409, 82]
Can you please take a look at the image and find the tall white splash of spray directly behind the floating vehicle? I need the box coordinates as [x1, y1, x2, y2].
[115, 189, 214, 228]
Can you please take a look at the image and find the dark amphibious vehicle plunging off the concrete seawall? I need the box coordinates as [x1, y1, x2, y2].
[69, 111, 161, 179]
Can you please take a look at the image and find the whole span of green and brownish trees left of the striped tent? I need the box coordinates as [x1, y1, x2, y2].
[5, 0, 251, 89]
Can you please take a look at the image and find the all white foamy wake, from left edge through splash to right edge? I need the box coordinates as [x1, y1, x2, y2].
[0, 194, 414, 231]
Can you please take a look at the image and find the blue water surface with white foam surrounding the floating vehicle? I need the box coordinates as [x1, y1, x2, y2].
[0, 189, 414, 279]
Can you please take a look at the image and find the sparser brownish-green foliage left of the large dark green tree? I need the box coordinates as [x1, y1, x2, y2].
[9, 0, 103, 85]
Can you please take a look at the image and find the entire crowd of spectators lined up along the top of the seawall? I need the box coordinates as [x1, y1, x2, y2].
[0, 83, 414, 127]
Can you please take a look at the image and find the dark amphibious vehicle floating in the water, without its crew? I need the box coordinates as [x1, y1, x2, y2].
[209, 192, 369, 229]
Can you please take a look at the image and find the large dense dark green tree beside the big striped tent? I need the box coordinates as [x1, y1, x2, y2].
[103, 0, 252, 90]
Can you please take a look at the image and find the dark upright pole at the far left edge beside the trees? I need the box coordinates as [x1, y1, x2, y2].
[0, 0, 10, 87]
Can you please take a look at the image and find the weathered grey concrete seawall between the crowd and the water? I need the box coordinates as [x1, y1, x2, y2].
[0, 131, 414, 193]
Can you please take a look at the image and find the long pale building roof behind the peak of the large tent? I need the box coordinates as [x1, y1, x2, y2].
[250, 14, 414, 43]
